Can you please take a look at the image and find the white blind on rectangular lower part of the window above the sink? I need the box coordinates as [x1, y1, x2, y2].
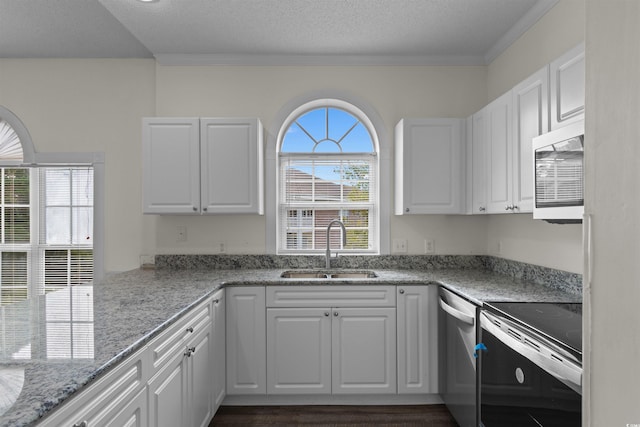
[279, 153, 378, 253]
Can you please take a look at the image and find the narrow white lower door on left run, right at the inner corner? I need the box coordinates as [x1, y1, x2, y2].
[212, 289, 227, 413]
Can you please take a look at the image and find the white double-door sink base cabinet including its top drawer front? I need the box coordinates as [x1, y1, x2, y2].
[267, 286, 397, 394]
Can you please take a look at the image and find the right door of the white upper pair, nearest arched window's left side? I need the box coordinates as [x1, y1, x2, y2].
[200, 118, 263, 214]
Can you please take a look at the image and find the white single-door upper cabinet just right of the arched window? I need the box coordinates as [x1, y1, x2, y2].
[395, 118, 464, 215]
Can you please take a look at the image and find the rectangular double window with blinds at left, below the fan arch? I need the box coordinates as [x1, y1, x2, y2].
[0, 167, 93, 305]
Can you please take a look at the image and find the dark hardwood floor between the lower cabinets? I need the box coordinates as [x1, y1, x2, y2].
[209, 405, 458, 427]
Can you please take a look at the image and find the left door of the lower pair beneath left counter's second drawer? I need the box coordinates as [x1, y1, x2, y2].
[148, 353, 189, 427]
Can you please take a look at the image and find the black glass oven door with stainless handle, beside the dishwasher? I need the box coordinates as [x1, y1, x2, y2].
[479, 311, 582, 427]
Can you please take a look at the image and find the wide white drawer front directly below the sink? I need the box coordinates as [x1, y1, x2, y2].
[267, 285, 396, 307]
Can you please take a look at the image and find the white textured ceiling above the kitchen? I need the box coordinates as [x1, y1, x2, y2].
[0, 0, 557, 64]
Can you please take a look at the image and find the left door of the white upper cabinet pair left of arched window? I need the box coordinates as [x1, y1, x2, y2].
[142, 117, 200, 214]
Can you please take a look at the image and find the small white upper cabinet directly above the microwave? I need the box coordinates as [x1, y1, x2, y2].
[549, 44, 585, 130]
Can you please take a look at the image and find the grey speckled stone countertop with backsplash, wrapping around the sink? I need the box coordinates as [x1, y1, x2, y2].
[0, 256, 581, 427]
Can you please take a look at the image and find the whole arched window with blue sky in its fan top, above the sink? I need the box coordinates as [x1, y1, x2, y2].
[277, 99, 379, 254]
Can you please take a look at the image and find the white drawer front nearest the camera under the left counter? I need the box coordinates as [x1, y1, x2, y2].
[40, 347, 150, 427]
